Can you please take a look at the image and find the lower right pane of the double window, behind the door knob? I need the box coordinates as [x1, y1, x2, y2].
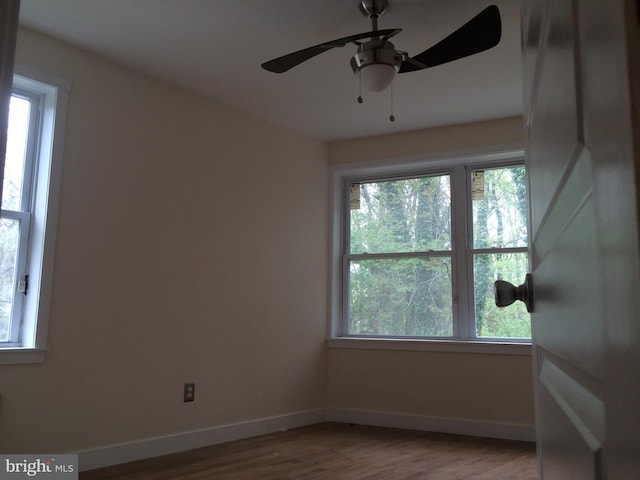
[473, 253, 531, 338]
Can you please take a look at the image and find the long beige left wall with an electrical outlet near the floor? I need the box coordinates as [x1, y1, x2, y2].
[0, 30, 327, 453]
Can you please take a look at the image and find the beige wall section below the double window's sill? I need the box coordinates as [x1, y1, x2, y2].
[327, 348, 533, 426]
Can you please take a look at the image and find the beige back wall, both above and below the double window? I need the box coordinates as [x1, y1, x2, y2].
[327, 118, 534, 426]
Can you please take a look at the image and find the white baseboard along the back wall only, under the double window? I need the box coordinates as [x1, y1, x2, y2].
[325, 408, 535, 442]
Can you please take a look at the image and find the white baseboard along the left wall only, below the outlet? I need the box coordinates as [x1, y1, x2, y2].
[76, 410, 325, 471]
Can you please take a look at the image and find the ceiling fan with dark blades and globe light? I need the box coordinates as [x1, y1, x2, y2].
[262, 0, 502, 94]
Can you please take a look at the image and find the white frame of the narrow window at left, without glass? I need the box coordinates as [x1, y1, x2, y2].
[0, 65, 71, 365]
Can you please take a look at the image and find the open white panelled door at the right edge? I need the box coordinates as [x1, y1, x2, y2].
[523, 0, 640, 480]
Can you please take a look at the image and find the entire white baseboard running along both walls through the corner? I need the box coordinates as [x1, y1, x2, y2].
[75, 408, 535, 471]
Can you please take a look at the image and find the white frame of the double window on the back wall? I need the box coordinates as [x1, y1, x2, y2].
[327, 146, 531, 355]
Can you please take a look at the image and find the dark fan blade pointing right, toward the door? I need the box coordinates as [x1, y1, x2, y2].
[399, 5, 502, 73]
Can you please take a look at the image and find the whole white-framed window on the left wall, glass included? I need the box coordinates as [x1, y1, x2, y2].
[0, 67, 69, 364]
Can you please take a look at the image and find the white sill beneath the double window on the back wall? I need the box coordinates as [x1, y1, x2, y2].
[327, 337, 531, 356]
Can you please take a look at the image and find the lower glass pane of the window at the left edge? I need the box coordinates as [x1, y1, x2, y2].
[0, 218, 20, 342]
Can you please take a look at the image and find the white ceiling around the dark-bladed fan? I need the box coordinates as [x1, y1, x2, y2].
[20, 0, 522, 140]
